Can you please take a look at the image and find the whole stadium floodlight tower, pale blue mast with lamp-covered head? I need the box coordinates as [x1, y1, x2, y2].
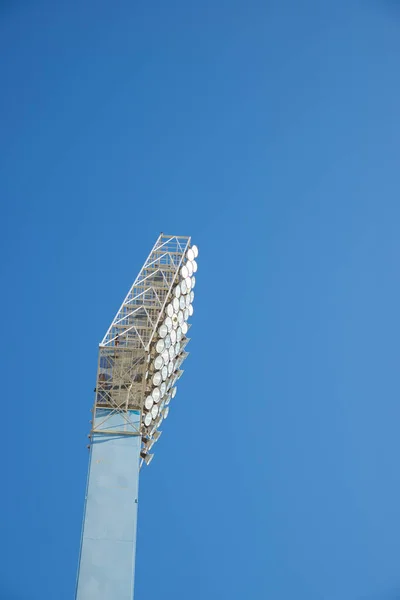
[75, 234, 198, 600]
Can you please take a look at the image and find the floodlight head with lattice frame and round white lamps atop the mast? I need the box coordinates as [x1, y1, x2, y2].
[93, 234, 198, 464]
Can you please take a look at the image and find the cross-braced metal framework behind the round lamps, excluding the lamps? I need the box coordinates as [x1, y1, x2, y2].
[91, 234, 190, 435]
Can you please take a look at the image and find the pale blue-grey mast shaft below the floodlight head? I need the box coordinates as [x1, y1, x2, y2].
[76, 411, 141, 600]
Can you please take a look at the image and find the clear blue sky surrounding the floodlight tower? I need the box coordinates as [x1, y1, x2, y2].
[0, 0, 400, 600]
